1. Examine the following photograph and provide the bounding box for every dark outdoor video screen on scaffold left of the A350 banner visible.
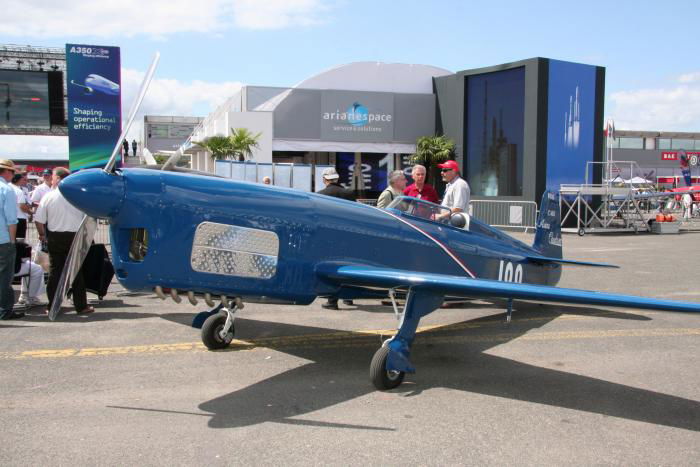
[0,70,51,129]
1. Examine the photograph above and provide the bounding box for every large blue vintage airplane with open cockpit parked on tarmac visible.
[52,167,700,390]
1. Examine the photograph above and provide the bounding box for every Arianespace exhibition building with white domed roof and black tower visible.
[188,58,605,201]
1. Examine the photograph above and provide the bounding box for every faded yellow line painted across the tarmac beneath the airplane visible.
[0,325,700,360]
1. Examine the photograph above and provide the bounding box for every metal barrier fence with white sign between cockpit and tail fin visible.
[469,200,537,232]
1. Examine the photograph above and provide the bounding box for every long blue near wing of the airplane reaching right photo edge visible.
[316,263,700,313]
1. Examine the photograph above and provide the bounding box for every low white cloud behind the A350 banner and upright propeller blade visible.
[0,69,241,159]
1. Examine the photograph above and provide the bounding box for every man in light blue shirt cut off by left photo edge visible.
[0,159,19,319]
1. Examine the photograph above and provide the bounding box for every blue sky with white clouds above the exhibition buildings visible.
[0,0,700,157]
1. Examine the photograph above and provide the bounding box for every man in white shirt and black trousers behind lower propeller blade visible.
[34,167,95,314]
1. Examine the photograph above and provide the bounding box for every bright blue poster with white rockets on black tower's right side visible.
[547,60,596,190]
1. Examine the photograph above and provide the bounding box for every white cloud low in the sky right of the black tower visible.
[607,73,700,131]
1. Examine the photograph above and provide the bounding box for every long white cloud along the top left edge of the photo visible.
[0,0,327,38]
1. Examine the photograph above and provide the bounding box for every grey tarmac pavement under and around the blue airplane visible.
[0,233,700,465]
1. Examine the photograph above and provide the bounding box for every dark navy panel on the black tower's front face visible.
[465,67,525,196]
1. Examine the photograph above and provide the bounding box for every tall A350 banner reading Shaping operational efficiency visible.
[66,44,121,170]
